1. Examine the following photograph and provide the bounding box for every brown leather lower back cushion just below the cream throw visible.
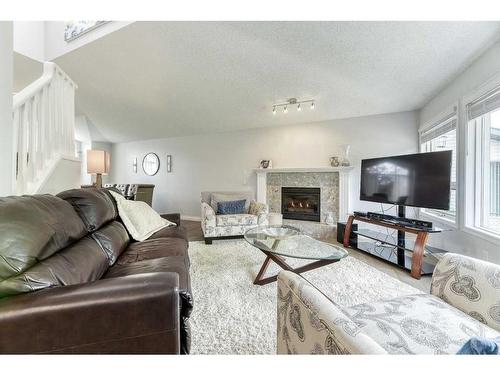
[92,221,130,266]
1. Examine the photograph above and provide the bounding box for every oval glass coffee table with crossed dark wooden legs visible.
[245,225,348,285]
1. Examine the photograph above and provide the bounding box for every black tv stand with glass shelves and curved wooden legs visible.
[344,206,443,279]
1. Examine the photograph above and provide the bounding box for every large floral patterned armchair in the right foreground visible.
[277,253,500,354]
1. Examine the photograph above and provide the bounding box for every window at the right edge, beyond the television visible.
[467,88,500,235]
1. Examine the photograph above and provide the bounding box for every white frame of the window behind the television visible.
[418,103,460,229]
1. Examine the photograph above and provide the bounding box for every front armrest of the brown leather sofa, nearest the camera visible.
[0,272,180,353]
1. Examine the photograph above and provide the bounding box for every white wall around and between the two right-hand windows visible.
[420,37,500,263]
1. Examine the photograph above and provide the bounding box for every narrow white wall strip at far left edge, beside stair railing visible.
[0,22,15,197]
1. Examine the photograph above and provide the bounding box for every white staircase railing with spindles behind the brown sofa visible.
[13,62,77,195]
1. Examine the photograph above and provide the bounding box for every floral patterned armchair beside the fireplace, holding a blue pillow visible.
[201,191,269,244]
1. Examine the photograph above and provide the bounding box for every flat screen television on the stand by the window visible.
[360,151,452,210]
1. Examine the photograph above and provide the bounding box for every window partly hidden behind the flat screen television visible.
[420,113,457,222]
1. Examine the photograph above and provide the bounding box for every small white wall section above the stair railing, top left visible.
[14,21,45,61]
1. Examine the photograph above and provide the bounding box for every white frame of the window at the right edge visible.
[460,74,500,245]
